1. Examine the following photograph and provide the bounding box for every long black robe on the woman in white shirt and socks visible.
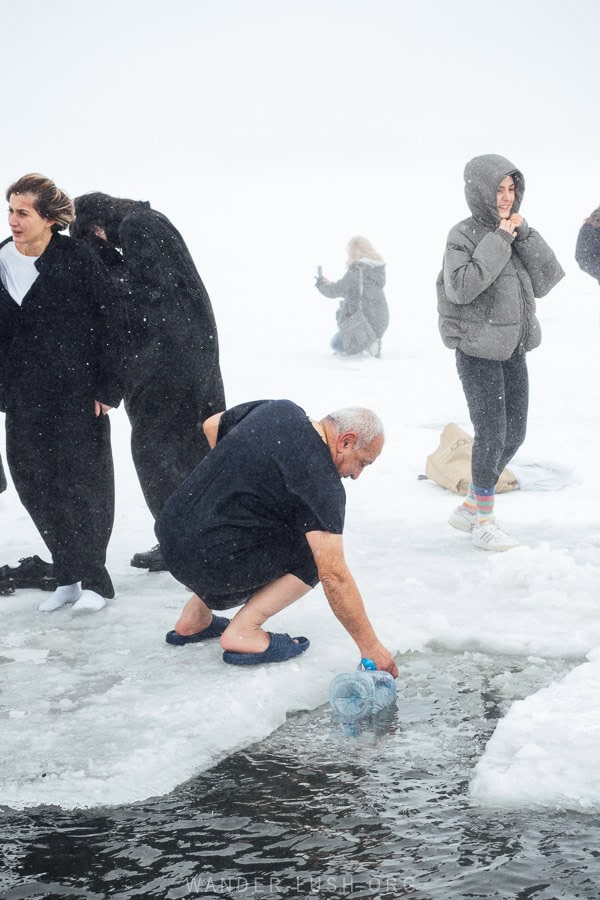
[0,234,123,597]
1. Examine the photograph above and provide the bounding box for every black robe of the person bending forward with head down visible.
[97,203,225,518]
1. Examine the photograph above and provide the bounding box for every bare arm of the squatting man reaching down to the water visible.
[306,531,398,677]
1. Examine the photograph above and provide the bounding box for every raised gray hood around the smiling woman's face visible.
[465,153,525,226]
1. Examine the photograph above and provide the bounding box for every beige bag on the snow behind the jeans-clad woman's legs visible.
[425,422,519,497]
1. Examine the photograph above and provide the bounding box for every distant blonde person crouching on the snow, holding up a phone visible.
[316,235,390,357]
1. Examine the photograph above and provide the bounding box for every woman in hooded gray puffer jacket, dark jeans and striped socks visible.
[437,154,564,550]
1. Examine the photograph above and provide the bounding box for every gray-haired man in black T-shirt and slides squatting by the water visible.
[156,400,398,676]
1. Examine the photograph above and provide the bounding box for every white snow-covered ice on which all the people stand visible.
[0,190,600,810]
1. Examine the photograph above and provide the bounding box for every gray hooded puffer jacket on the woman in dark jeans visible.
[436,154,565,360]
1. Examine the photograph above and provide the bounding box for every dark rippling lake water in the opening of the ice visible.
[0,652,600,900]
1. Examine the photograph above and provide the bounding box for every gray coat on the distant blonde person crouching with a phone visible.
[316,259,390,338]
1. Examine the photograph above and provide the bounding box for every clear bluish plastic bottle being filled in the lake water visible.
[329,658,396,722]
